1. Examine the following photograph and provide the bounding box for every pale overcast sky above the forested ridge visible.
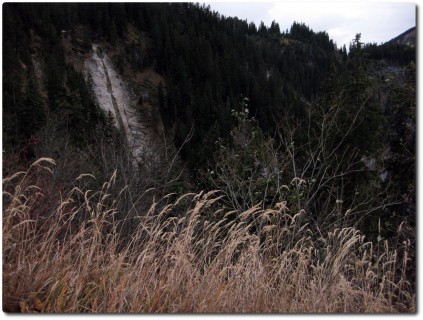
[206,0,416,48]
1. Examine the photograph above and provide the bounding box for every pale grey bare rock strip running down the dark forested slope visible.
[85,44,148,162]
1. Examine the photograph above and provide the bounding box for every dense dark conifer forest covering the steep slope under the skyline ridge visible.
[4,3,342,163]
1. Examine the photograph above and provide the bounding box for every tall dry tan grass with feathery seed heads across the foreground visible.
[3,159,416,313]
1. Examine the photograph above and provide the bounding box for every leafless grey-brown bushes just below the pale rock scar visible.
[31,120,189,233]
